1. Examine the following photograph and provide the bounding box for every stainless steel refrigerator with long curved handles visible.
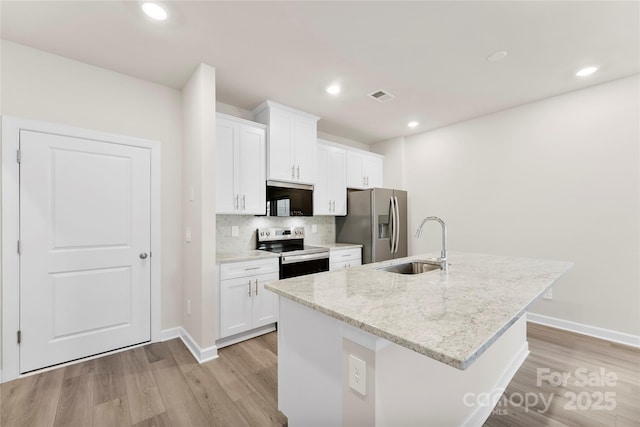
[336,188,407,264]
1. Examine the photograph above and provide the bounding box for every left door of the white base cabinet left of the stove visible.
[220,277,253,338]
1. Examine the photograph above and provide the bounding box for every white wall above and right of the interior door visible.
[0,41,182,344]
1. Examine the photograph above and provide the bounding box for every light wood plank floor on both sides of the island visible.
[0,324,640,427]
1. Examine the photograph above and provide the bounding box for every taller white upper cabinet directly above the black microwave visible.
[253,101,320,184]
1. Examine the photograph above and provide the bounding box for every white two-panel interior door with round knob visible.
[20,130,151,373]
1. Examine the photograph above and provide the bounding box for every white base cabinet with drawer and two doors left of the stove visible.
[220,258,279,338]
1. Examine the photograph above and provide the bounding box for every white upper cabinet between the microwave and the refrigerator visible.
[313,140,347,215]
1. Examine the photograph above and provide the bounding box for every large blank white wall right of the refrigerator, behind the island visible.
[374,75,640,335]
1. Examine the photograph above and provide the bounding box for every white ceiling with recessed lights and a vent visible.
[1,1,640,143]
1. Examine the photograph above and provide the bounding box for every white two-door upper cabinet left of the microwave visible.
[216,113,266,215]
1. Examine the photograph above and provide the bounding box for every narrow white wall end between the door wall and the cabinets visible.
[182,64,218,349]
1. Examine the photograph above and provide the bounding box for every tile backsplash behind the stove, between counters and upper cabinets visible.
[216,215,336,253]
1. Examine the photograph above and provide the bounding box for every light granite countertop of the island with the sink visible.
[265,252,573,369]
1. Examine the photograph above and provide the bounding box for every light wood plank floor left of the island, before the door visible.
[0,333,287,427]
